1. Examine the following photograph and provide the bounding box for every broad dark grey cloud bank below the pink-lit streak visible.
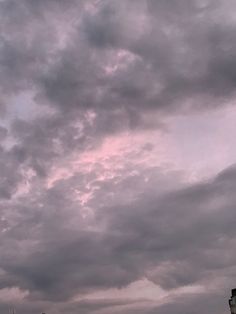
[1,164,235,300]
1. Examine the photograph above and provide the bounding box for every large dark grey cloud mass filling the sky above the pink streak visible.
[0,1,235,186]
